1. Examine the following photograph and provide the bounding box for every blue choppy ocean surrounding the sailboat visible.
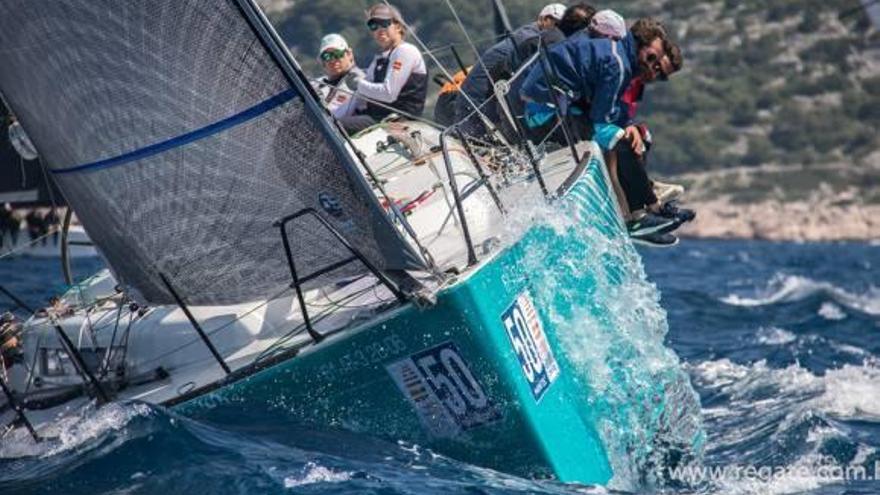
[0,240,880,495]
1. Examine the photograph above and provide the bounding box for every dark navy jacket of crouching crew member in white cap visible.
[455,22,565,131]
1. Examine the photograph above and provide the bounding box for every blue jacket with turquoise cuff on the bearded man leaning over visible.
[520,33,638,150]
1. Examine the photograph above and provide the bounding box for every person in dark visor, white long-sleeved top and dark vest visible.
[339,3,428,134]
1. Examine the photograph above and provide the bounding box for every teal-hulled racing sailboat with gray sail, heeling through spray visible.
[0,0,702,484]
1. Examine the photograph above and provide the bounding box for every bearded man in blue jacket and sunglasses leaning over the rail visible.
[520,19,677,244]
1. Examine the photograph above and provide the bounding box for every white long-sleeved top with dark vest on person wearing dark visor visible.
[357,41,428,120]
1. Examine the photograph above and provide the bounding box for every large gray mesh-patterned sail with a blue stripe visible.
[0,0,424,304]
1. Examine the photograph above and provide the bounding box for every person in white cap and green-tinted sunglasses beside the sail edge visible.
[312,33,364,119]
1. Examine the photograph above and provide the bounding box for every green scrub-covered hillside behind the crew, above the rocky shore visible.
[273,0,880,173]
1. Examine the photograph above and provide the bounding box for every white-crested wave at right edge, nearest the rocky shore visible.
[721,274,880,320]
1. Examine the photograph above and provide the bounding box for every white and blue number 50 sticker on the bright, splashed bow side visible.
[501,291,559,401]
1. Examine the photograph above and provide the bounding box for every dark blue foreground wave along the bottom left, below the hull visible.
[0,403,608,495]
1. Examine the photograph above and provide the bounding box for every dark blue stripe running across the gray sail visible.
[52,89,297,175]
